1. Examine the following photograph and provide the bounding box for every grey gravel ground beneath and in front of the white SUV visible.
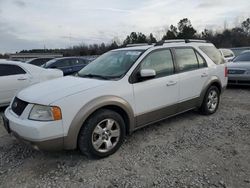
[0,88,250,188]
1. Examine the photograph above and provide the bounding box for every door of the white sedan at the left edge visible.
[0,64,30,105]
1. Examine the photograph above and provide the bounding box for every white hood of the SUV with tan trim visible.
[17,76,110,105]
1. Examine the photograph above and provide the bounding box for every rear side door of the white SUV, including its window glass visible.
[174,47,208,111]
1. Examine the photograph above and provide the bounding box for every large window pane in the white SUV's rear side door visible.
[175,48,199,72]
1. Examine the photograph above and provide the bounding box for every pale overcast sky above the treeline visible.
[0,0,250,53]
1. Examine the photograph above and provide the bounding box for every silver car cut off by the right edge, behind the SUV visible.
[227,52,250,86]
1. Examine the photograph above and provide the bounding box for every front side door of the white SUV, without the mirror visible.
[133,49,179,127]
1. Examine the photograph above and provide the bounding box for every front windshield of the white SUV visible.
[77,50,143,79]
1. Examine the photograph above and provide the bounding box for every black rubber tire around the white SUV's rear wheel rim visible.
[200,86,220,115]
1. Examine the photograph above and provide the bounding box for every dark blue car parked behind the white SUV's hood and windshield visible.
[42,57,92,76]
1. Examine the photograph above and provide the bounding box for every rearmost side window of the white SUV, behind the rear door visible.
[199,46,225,65]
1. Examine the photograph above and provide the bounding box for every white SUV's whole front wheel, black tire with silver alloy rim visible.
[78,109,125,158]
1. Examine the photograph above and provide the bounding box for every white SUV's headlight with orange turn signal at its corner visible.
[29,104,62,121]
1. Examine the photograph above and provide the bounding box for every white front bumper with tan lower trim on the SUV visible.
[3,108,64,151]
